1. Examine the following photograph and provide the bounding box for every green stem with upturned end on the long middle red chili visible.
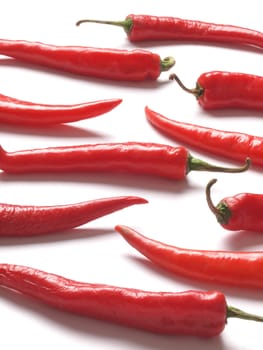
[188,155,251,173]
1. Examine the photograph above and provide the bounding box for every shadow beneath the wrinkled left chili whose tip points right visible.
[0,227,114,247]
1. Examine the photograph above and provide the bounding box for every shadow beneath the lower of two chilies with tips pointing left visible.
[127,255,263,302]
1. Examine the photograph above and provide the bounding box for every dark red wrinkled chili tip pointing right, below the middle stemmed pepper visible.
[0,196,147,236]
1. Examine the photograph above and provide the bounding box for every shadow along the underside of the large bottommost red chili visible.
[0,287,227,350]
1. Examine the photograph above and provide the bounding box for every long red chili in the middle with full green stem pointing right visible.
[0,142,250,180]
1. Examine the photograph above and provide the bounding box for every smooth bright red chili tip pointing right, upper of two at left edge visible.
[0,94,122,126]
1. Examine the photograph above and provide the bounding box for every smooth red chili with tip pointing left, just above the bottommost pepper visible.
[116,225,263,289]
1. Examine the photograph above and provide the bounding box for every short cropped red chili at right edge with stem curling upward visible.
[206,179,263,232]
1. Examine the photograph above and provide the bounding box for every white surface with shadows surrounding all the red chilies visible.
[0,0,263,350]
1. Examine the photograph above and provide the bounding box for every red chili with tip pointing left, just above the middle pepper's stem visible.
[145,107,263,166]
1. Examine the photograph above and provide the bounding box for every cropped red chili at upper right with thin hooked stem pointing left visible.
[169,71,263,111]
